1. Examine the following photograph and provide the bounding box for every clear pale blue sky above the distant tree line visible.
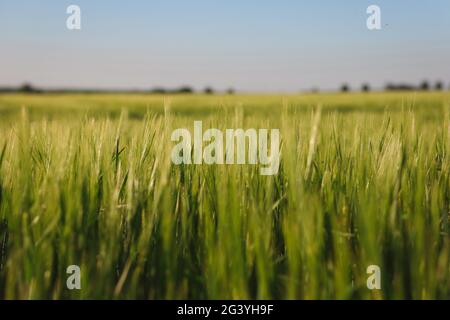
[0,0,450,92]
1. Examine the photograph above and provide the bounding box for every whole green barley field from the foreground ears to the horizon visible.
[0,92,450,299]
